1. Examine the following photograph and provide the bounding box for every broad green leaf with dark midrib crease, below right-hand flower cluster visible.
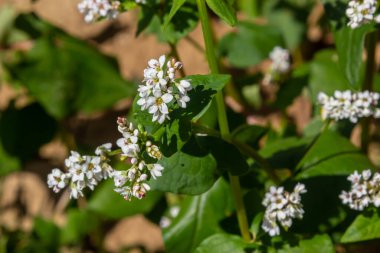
[296,131,373,179]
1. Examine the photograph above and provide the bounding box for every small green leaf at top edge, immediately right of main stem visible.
[206,0,237,26]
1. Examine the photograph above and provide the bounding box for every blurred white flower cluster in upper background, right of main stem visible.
[263,46,291,84]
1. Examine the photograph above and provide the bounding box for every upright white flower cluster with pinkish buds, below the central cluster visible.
[113,118,164,200]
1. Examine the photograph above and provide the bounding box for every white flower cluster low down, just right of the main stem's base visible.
[261,183,306,236]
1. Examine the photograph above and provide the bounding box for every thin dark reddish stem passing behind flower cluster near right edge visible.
[361,31,377,153]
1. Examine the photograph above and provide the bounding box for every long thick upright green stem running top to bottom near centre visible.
[197,0,251,242]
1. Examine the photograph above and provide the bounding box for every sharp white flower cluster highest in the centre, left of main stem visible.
[137,55,192,124]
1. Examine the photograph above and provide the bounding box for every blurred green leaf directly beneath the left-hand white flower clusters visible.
[87,180,162,220]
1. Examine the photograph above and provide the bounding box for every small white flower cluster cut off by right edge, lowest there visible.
[339,170,380,211]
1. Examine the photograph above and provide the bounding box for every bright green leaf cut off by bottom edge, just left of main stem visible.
[195,234,247,253]
